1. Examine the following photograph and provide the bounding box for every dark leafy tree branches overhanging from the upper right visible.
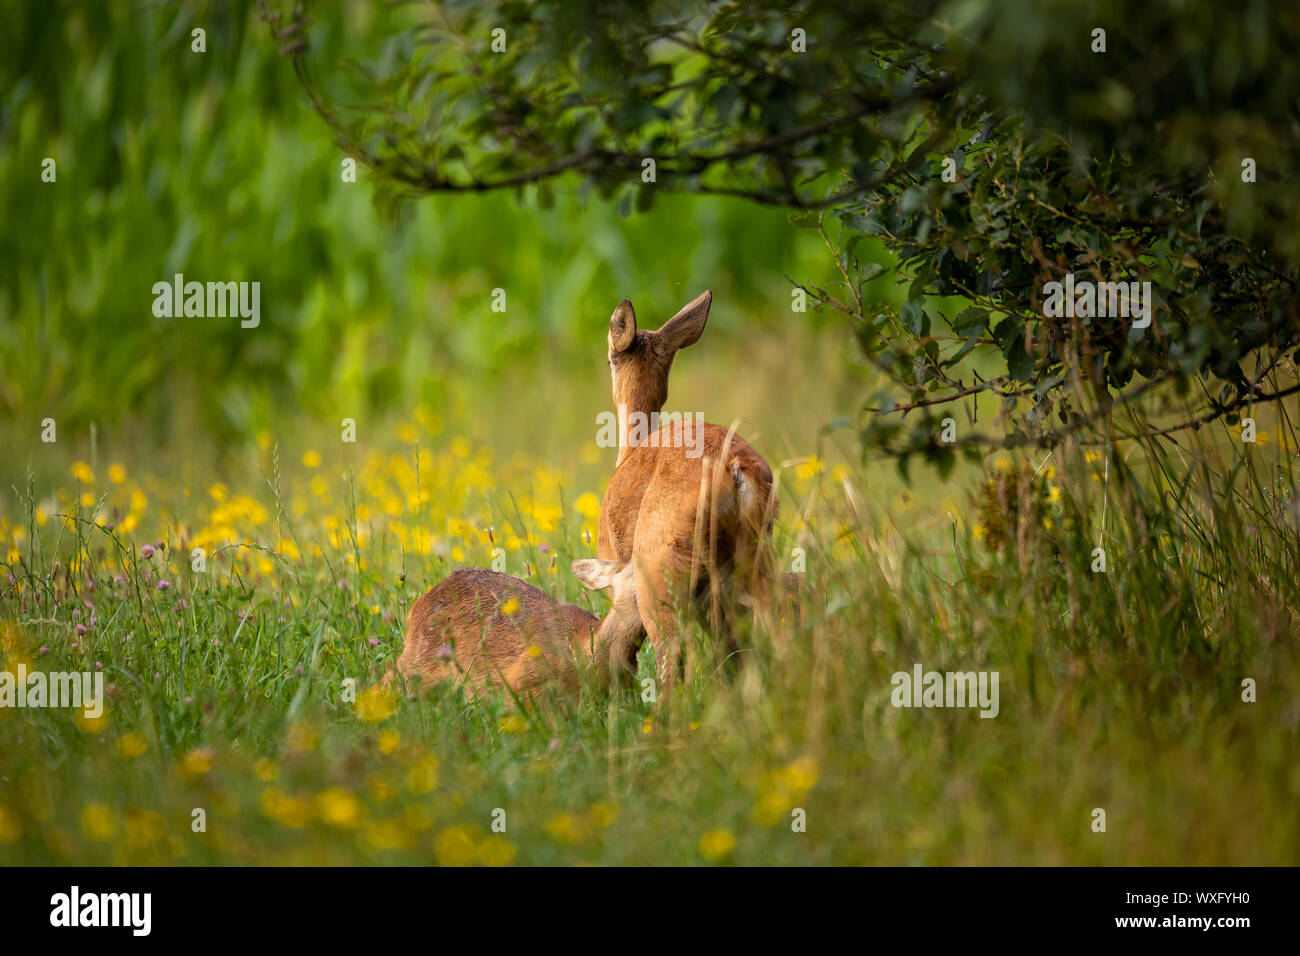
[267,0,1300,467]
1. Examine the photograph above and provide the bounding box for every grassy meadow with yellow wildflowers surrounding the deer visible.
[0,362,1300,865]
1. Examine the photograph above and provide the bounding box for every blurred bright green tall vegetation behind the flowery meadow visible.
[0,3,901,502]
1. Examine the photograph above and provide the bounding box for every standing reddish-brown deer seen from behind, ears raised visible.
[597,291,776,689]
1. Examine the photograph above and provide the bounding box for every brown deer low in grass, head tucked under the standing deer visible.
[384,559,641,698]
